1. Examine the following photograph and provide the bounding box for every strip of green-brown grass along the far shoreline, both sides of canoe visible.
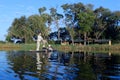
[0,43,120,53]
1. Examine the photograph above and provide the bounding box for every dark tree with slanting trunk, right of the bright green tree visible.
[93,7,111,39]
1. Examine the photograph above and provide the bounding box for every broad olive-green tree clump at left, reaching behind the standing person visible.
[7,15,48,43]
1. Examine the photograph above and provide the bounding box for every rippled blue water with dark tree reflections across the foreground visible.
[0,51,120,80]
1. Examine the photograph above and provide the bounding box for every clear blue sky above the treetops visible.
[0,0,120,41]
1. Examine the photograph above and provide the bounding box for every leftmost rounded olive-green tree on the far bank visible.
[8,16,31,43]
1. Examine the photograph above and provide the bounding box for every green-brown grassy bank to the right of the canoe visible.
[55,44,120,52]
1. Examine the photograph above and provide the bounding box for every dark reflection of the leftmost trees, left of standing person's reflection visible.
[8,51,36,80]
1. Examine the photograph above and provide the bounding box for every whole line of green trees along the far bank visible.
[6,2,120,44]
